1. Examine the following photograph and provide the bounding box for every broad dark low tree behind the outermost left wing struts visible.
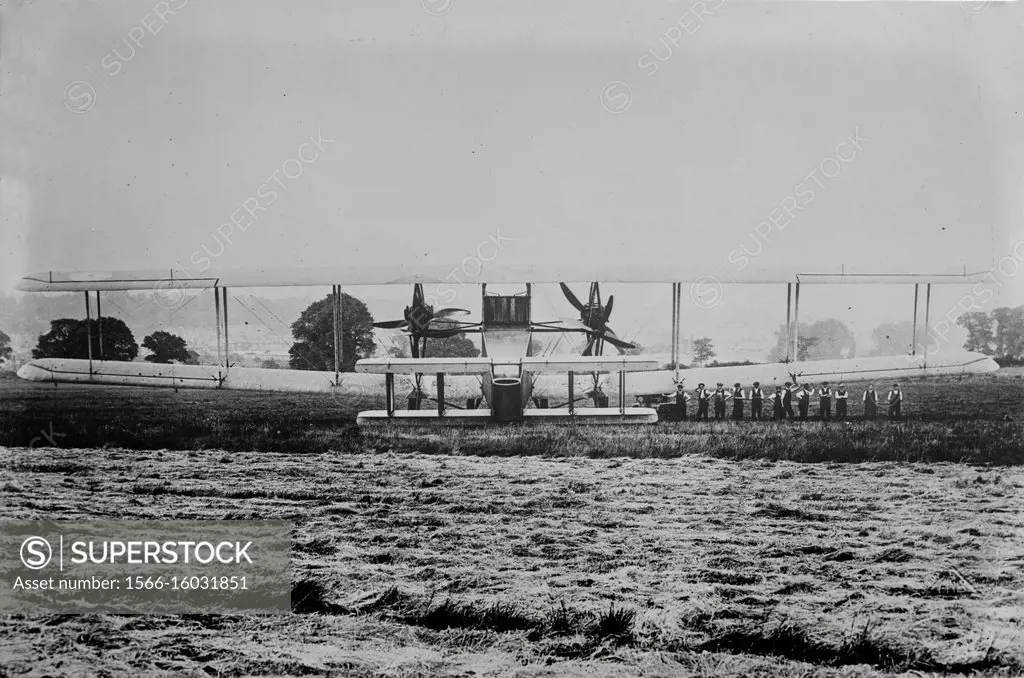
[32,315,138,361]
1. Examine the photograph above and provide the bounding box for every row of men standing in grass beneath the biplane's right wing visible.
[676,381,903,421]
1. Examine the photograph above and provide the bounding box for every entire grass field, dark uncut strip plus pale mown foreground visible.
[0,371,1024,676]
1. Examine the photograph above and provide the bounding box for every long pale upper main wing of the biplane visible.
[17,263,987,292]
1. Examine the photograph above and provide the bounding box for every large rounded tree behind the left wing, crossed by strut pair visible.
[288,293,375,372]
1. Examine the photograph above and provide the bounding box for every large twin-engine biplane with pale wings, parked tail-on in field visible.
[17,264,998,425]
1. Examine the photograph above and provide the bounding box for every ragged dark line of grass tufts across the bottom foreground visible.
[284,580,1024,674]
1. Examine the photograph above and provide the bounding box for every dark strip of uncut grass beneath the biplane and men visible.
[0,368,1024,464]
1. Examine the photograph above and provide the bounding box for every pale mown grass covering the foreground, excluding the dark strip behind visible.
[8,446,1024,678]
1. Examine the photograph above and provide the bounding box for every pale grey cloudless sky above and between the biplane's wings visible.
[0,0,1024,356]
